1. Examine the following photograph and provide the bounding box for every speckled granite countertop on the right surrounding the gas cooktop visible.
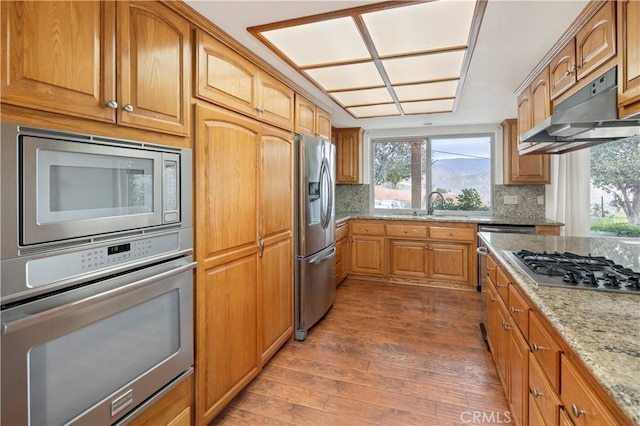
[478,232,640,425]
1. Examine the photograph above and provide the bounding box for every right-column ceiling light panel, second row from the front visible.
[382,50,465,84]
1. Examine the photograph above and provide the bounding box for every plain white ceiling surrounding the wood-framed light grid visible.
[185,0,587,130]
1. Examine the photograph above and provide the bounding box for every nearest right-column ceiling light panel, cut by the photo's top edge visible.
[362,0,476,57]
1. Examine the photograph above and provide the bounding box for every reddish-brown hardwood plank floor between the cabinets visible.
[212,279,509,425]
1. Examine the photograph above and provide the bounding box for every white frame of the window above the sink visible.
[367,131,496,216]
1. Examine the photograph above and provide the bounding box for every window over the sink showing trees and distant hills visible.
[371,134,494,215]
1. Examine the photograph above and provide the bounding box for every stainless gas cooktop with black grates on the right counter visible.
[504,250,640,294]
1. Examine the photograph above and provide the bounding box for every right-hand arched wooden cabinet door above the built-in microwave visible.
[117,1,191,135]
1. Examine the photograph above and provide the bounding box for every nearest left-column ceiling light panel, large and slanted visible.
[261,16,371,67]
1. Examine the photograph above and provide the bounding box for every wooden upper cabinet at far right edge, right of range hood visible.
[617,0,640,118]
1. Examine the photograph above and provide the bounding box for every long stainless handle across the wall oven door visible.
[2,262,198,334]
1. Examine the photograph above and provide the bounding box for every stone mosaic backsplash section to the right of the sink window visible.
[493,185,545,219]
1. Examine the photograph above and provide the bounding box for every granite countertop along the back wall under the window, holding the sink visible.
[336,213,564,226]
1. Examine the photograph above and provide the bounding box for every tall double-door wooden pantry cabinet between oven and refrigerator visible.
[195,105,293,423]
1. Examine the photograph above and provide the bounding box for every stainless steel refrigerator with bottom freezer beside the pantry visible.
[295,135,336,340]
